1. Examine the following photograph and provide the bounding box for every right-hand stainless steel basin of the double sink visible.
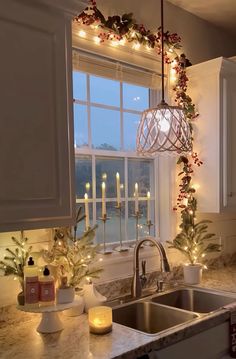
[152,288,236,313]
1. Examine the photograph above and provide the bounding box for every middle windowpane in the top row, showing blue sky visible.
[90,76,120,107]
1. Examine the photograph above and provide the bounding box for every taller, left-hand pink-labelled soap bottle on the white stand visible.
[24,257,39,308]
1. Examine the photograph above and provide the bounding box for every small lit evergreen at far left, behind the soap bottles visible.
[0,231,32,291]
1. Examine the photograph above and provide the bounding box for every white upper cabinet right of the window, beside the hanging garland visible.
[187,57,236,213]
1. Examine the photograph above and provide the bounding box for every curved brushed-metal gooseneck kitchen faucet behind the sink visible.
[131,237,170,298]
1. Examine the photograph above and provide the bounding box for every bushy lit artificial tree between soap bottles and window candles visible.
[43,207,102,288]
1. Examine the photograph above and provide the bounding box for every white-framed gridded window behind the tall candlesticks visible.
[73,71,156,243]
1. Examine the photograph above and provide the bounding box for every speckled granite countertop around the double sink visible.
[0,265,236,359]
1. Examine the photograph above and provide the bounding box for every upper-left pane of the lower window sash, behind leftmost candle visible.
[75,156,92,198]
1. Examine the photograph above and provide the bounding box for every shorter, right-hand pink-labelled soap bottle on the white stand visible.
[39,267,55,306]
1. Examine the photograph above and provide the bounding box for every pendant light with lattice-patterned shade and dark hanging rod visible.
[136,0,192,155]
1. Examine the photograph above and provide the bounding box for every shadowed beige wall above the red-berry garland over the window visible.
[97,0,236,64]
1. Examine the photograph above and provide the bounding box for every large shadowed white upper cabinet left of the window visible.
[0,0,75,231]
